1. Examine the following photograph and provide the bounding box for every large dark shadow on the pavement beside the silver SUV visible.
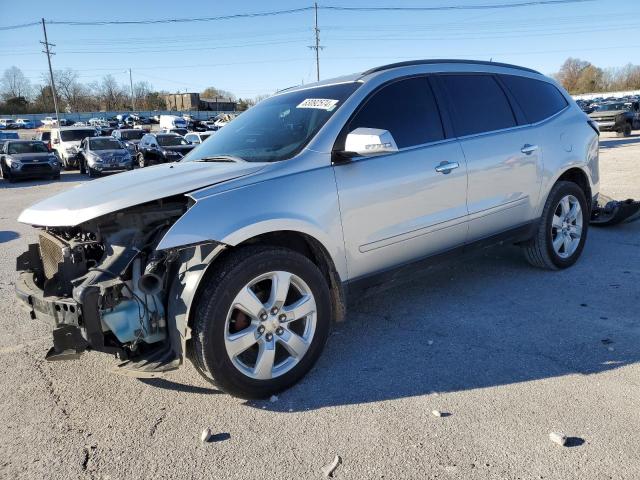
[245,222,640,412]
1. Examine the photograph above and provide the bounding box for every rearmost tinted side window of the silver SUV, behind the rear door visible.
[500,75,567,123]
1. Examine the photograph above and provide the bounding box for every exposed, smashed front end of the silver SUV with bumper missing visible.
[16,196,190,372]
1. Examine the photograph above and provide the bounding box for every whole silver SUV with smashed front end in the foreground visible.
[17,60,598,398]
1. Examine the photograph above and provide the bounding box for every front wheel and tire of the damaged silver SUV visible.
[190,246,333,399]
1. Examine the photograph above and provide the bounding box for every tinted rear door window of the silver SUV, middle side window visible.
[440,75,516,136]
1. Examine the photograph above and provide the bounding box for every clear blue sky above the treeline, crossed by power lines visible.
[0,0,640,97]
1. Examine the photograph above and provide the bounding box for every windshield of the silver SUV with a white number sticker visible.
[183,82,360,162]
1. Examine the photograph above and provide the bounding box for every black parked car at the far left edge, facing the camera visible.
[0,140,60,182]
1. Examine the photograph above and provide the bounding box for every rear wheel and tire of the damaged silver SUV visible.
[524,181,590,270]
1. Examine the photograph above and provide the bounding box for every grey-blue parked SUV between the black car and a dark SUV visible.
[78,137,133,177]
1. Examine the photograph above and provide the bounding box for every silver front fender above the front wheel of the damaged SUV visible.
[157,166,347,279]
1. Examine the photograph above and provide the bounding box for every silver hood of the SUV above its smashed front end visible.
[18,162,264,227]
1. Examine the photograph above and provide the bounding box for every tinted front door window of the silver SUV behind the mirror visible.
[349,77,444,148]
